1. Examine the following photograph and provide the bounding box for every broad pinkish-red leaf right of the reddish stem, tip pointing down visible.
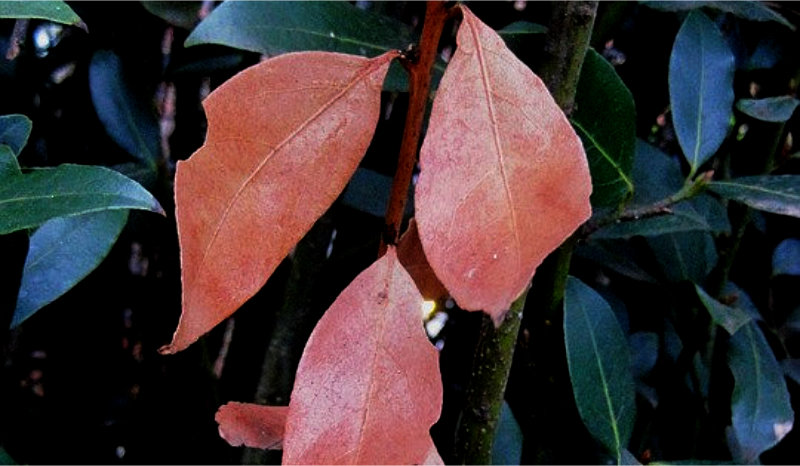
[416,5,591,323]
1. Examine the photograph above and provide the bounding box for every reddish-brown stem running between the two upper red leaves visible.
[379,1,451,256]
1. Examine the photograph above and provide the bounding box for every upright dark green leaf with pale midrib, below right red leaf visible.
[564,277,636,463]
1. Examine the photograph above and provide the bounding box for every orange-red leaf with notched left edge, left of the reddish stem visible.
[161,52,397,353]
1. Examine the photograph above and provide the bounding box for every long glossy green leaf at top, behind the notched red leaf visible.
[185,1,412,91]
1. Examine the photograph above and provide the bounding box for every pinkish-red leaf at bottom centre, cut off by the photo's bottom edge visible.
[283,247,442,464]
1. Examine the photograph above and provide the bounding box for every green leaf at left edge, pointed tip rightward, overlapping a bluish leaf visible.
[0,164,164,234]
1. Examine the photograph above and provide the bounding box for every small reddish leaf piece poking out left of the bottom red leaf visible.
[214,402,289,450]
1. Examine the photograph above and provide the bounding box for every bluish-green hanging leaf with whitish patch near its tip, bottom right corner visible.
[728,322,794,464]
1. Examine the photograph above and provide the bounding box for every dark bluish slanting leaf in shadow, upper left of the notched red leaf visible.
[89,50,161,171]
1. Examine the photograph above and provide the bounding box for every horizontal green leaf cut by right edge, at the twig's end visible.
[709,175,800,217]
